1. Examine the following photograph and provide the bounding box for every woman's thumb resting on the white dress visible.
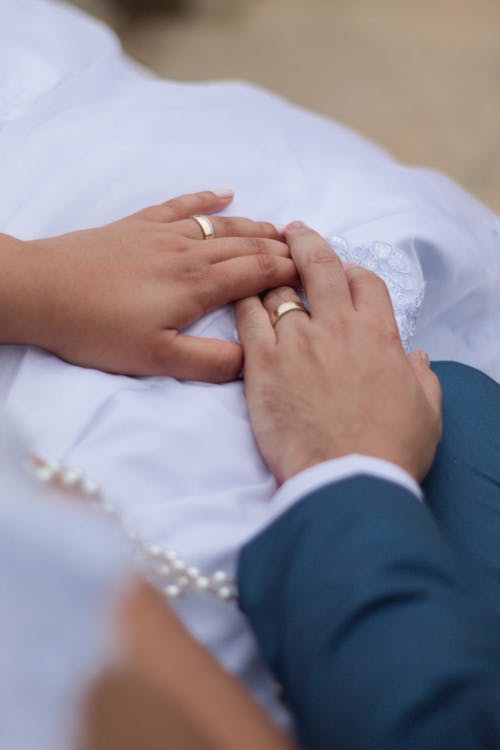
[155,331,243,383]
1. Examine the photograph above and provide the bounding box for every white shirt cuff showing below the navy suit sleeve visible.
[272,453,424,516]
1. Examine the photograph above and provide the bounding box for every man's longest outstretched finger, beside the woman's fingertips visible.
[285,222,352,319]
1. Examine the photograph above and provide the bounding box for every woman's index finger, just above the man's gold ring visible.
[207,255,298,307]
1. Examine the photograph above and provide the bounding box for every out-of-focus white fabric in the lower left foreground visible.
[0,426,131,750]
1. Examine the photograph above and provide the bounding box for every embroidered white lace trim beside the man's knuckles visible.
[328,236,425,352]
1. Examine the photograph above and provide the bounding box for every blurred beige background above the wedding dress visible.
[74,0,500,212]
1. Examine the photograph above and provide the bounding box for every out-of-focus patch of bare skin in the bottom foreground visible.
[79,581,295,750]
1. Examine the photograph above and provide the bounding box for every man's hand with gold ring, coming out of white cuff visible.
[236,223,441,482]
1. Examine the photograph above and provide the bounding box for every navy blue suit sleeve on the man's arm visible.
[239,476,500,750]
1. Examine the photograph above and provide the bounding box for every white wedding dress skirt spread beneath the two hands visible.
[0,0,500,736]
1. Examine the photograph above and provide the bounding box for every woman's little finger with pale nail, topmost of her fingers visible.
[129,190,234,223]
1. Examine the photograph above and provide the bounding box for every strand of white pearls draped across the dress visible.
[30,456,237,602]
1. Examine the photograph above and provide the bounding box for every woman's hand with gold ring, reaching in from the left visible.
[7,192,295,382]
